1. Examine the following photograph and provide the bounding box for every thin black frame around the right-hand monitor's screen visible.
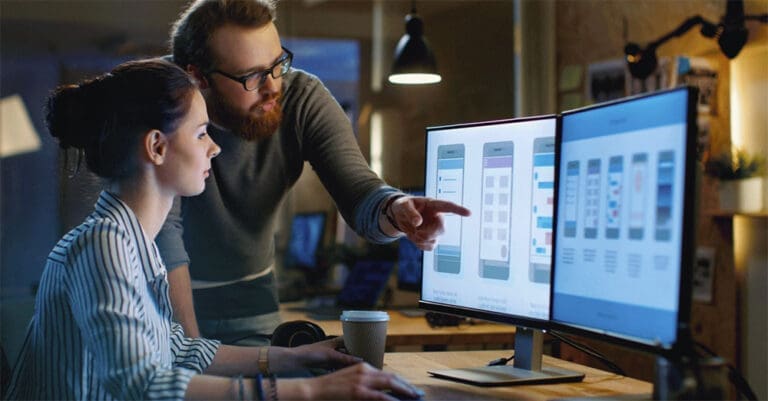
[549,86,698,356]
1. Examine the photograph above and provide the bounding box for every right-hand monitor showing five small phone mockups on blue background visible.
[551,88,696,349]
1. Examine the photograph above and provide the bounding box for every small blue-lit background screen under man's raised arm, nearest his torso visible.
[284,212,325,269]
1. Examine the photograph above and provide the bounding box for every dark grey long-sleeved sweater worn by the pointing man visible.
[156,69,396,316]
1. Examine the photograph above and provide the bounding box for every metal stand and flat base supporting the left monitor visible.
[428,326,584,386]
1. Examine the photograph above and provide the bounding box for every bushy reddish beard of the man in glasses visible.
[208,88,283,141]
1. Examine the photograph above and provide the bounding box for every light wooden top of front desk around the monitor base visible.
[384,351,653,400]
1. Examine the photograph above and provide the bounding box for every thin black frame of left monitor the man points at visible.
[419,114,560,330]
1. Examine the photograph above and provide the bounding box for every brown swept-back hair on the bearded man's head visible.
[171,0,277,72]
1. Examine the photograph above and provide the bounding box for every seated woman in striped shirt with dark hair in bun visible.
[7,59,415,400]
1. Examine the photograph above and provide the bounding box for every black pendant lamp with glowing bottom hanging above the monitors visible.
[389,14,441,84]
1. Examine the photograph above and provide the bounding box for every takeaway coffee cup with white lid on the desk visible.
[341,310,389,369]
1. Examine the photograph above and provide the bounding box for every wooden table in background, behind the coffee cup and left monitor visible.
[280,303,515,347]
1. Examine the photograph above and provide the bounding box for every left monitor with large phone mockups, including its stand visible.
[419,115,583,385]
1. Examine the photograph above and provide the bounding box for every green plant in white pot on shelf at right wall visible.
[704,148,765,212]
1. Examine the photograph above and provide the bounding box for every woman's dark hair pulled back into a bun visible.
[43,58,196,180]
